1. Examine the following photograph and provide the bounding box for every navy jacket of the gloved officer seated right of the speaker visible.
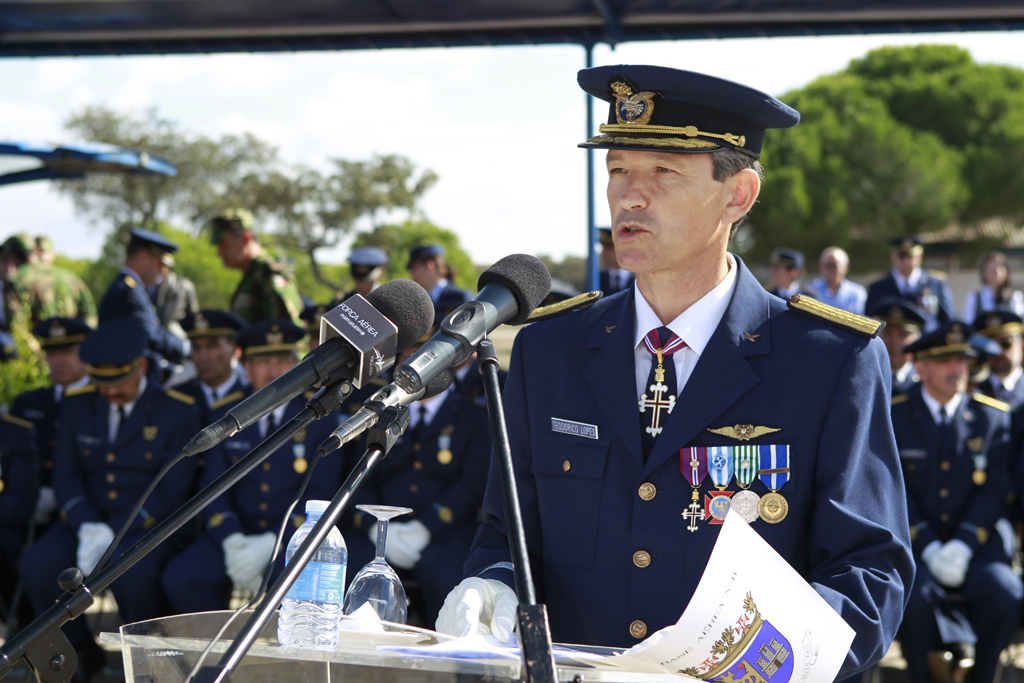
[892,385,1013,561]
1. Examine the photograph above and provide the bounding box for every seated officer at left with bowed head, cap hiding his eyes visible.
[18,318,200,672]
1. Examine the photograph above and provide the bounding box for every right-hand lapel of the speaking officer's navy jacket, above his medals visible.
[644,258,771,471]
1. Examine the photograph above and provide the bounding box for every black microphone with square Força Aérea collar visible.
[183,280,434,456]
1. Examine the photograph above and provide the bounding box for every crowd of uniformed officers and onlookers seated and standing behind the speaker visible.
[6,215,1024,681]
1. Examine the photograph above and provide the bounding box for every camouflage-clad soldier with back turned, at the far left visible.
[11,236,96,326]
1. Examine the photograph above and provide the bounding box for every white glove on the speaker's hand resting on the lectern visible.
[434,577,519,643]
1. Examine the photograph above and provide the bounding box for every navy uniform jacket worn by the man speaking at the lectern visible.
[466,258,913,678]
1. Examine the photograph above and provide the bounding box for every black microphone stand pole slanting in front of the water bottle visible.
[194,405,411,683]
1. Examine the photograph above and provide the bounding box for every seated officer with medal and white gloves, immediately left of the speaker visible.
[345,333,492,625]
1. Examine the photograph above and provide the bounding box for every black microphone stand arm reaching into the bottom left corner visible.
[0,380,352,683]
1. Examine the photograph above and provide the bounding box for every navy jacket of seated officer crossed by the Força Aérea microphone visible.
[200,396,342,544]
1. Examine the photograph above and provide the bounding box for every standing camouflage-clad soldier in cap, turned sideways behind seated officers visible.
[210,209,303,325]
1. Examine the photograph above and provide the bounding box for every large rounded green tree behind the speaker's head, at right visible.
[749,45,1024,269]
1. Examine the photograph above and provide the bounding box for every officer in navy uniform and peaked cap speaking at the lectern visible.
[437,66,913,678]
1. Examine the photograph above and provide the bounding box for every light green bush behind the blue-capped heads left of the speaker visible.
[352,220,478,292]
